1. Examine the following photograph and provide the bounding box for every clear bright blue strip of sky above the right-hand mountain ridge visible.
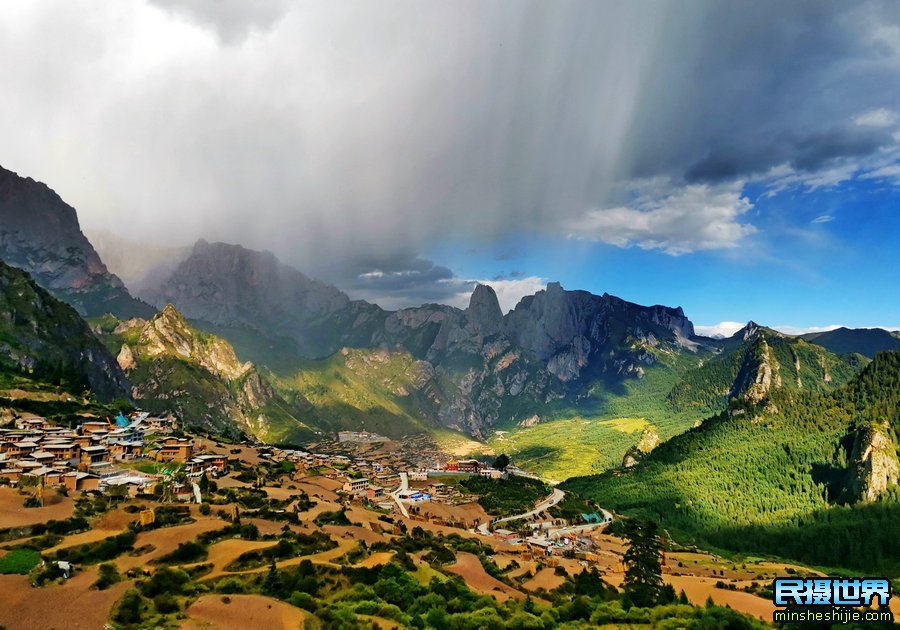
[428,179,900,331]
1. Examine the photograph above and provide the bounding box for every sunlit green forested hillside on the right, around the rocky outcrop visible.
[564,353,900,574]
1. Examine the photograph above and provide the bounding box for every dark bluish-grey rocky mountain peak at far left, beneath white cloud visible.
[0,167,152,316]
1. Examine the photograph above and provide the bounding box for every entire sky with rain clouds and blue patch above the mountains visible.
[0,0,900,333]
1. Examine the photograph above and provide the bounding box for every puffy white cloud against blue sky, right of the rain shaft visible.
[566,179,756,256]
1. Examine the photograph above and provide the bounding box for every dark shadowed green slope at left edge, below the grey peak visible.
[0,262,129,401]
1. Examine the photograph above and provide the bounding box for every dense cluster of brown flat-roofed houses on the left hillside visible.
[0,412,227,496]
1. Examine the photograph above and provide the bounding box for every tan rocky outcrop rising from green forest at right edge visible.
[844,423,900,503]
